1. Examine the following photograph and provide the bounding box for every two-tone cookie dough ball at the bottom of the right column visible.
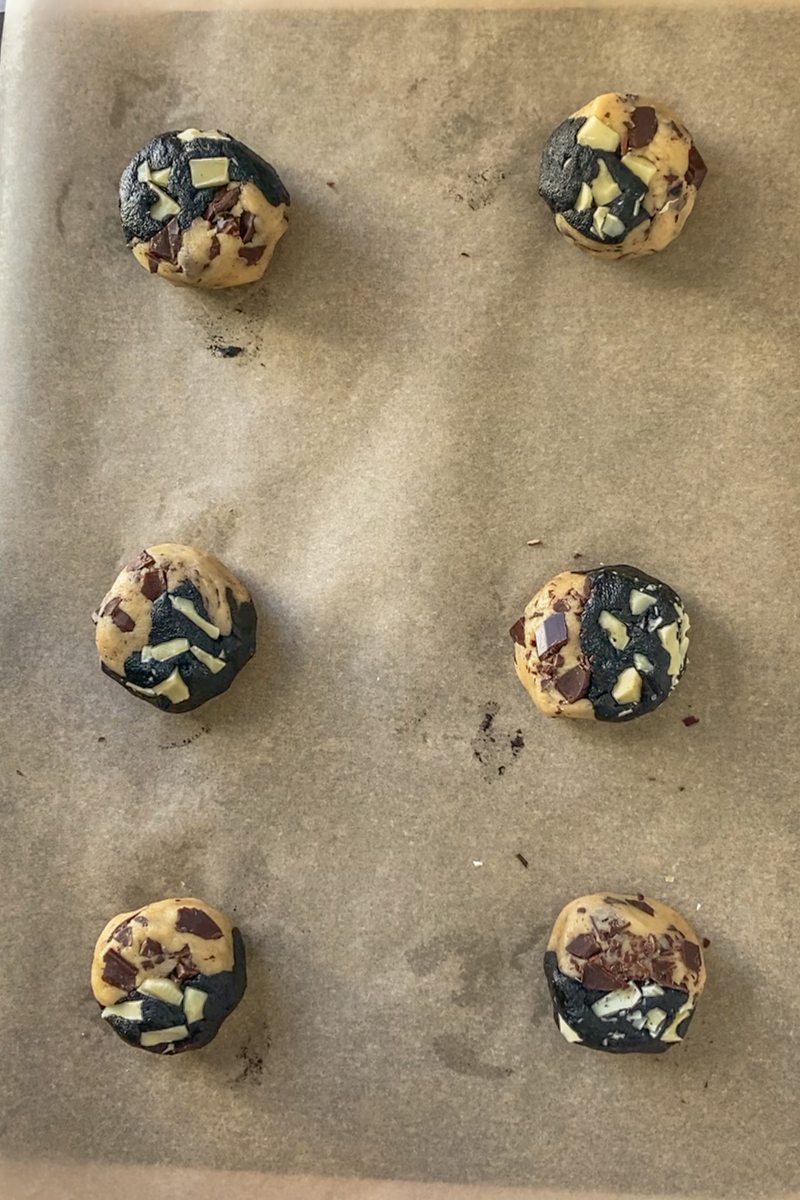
[545,892,705,1054]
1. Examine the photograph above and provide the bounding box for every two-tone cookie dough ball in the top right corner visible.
[539,91,705,258]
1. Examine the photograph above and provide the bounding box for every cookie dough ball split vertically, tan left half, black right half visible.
[511,565,690,721]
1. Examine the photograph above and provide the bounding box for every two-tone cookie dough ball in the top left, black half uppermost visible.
[120,130,289,288]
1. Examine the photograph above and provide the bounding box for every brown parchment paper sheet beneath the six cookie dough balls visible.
[0,7,800,1200]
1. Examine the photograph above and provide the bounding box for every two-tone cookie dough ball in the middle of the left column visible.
[92,542,255,713]
